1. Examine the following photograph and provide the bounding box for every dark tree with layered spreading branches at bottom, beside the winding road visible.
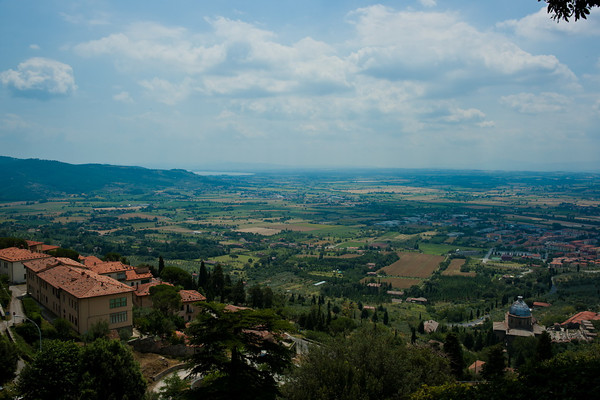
[187,303,291,400]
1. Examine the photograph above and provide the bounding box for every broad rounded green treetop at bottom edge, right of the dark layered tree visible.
[283,326,453,400]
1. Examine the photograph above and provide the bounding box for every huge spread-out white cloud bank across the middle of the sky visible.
[69,2,577,141]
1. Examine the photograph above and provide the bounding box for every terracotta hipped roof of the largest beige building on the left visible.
[38,265,135,298]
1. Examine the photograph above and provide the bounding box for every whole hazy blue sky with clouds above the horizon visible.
[0,0,600,171]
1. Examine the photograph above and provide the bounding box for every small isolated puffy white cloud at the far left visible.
[0,57,77,96]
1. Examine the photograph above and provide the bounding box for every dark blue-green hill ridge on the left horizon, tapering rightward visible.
[0,156,223,201]
